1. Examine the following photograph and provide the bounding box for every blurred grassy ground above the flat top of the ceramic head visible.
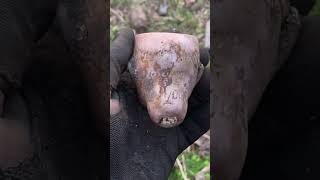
[110,0,210,47]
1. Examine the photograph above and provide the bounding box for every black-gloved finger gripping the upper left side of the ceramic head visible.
[110,28,134,89]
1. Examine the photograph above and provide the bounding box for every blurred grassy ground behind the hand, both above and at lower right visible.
[110,0,210,180]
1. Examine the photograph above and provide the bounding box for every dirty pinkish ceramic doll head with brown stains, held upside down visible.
[129,33,203,128]
